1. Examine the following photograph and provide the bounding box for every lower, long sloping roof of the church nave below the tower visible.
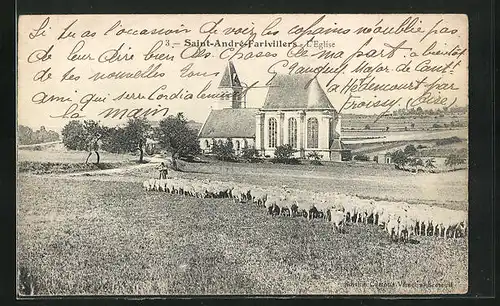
[198,108,258,138]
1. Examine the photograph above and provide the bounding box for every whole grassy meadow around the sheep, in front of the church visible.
[16,133,468,295]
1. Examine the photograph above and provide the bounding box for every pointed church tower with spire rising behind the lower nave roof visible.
[219,61,246,108]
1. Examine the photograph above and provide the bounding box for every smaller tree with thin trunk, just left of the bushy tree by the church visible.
[122,118,151,163]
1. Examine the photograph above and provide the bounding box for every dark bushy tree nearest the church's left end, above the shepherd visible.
[155,113,201,168]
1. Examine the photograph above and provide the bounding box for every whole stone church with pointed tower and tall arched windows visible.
[198,62,349,161]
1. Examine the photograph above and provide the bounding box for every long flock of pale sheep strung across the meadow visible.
[143,177,468,242]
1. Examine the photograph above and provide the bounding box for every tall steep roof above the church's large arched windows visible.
[262,74,334,109]
